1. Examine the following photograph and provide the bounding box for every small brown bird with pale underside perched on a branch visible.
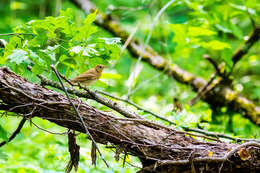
[71,64,105,86]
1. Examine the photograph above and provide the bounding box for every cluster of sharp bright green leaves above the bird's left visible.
[1,9,120,83]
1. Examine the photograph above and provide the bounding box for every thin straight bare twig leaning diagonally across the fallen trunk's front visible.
[51,65,110,168]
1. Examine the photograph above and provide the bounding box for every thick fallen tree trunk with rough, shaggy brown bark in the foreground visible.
[0,67,260,172]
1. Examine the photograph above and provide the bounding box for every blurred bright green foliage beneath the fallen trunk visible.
[0,117,140,173]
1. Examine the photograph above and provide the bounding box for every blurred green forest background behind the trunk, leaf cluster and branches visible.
[0,0,260,173]
